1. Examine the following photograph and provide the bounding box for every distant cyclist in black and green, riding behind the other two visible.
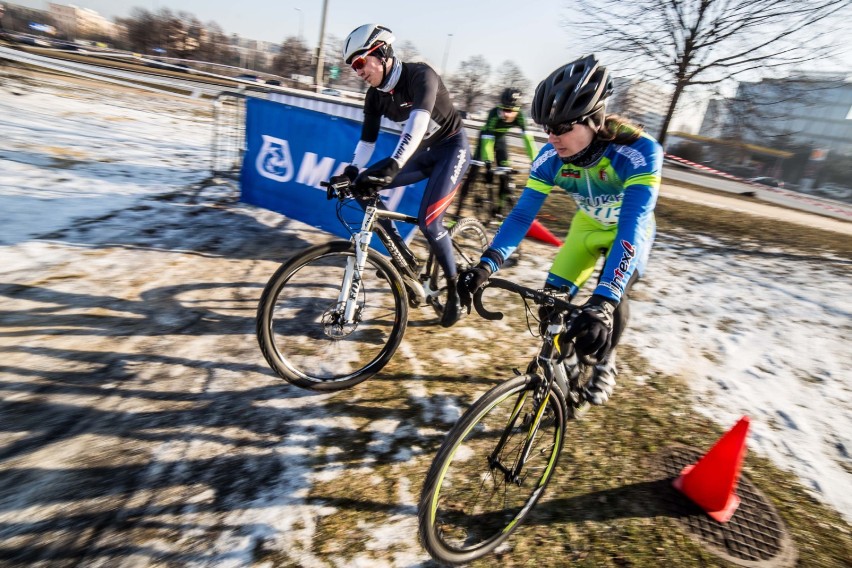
[456,88,536,217]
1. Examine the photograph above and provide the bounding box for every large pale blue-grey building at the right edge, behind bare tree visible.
[699,73,852,156]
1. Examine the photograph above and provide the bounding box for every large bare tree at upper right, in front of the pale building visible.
[570,0,852,143]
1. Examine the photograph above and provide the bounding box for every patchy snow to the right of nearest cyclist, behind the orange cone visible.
[629,231,852,519]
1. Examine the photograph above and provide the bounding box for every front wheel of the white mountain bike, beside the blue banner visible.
[257,241,408,391]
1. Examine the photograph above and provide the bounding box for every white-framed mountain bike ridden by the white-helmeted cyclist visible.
[256,178,489,391]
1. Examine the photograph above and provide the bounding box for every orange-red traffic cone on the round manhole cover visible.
[672,416,749,523]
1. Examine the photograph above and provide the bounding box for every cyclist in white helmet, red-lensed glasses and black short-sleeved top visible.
[330,24,470,327]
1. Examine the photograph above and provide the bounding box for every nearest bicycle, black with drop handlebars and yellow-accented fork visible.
[418,278,595,564]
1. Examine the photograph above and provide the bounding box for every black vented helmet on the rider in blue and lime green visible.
[530,55,612,126]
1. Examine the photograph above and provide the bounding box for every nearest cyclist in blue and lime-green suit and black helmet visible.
[459,55,663,404]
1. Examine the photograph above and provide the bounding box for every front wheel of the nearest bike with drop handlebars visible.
[418,375,565,564]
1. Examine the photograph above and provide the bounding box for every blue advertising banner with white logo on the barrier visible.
[240,98,426,245]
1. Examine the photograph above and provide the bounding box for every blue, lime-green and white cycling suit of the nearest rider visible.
[482,133,663,302]
